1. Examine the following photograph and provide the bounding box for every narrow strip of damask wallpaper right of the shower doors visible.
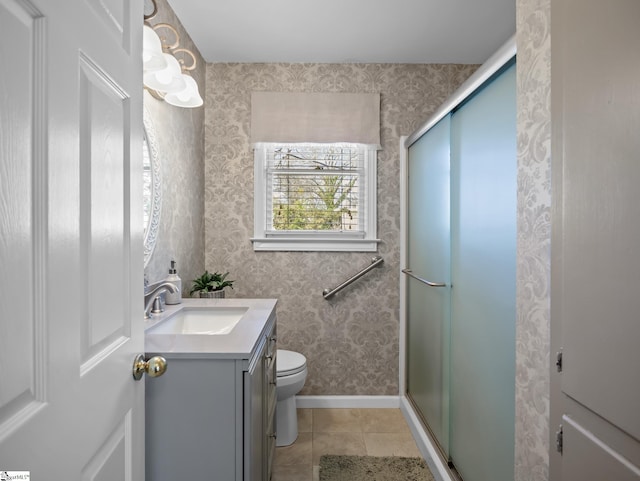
[515,0,551,481]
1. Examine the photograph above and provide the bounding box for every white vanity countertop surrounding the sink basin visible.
[145,298,277,359]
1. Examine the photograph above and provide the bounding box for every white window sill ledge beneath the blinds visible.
[251,237,381,252]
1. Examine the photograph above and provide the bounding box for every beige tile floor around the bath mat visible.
[271,409,420,481]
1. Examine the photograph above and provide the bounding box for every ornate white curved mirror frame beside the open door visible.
[143,108,162,267]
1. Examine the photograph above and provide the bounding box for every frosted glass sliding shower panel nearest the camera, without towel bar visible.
[450,65,517,481]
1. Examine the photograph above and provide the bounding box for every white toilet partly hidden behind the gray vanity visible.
[276,349,307,446]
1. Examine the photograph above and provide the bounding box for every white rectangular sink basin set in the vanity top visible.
[148,306,249,336]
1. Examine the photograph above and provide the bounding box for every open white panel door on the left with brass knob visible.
[0,0,144,481]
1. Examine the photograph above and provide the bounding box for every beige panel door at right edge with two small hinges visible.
[551,0,640,481]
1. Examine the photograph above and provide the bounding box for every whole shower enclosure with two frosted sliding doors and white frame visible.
[402,40,517,481]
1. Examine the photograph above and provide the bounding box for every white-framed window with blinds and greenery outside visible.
[252,143,378,251]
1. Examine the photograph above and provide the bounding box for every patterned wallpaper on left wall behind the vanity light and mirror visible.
[144,0,205,295]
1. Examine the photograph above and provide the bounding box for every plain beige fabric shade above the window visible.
[251,92,380,149]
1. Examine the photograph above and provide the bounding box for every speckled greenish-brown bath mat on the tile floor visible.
[320,454,434,481]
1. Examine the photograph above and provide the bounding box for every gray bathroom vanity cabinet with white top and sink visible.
[145,299,277,481]
